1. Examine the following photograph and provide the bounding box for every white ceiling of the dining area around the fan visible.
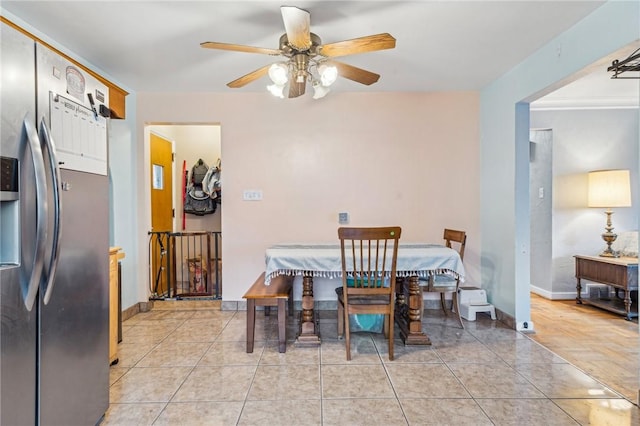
[0,0,638,103]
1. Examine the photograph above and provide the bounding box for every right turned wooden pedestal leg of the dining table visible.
[395,276,431,345]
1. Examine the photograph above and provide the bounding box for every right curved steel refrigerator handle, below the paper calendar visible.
[39,117,62,305]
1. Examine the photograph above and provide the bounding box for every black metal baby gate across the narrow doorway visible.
[149,231,222,299]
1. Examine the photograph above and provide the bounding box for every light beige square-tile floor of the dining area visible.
[102,301,640,426]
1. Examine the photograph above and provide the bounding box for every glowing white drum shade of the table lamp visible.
[587,170,631,208]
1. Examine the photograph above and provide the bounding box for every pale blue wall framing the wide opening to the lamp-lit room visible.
[480,1,640,321]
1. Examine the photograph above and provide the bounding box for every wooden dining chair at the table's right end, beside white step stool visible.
[420,228,467,329]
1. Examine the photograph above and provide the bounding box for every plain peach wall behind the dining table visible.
[136,92,480,301]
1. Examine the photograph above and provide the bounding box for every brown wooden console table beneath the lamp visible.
[574,255,638,320]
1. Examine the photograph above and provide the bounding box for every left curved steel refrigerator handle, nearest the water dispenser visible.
[22,115,48,311]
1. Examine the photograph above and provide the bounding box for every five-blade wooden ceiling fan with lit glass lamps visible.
[200,6,396,99]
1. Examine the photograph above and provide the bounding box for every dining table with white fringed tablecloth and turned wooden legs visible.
[265,243,465,345]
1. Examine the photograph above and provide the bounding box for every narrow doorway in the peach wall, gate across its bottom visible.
[145,123,222,299]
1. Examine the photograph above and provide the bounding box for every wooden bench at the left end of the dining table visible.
[242,272,293,353]
